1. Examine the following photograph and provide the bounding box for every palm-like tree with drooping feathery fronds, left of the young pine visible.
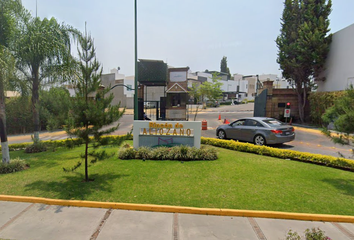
[14,17,75,140]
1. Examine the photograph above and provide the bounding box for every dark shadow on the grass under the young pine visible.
[25,173,129,200]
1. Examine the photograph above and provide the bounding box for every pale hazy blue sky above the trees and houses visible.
[22,0,354,76]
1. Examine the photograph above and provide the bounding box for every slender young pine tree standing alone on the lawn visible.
[66,28,124,181]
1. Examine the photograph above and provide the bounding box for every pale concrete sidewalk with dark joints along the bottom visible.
[0,201,354,240]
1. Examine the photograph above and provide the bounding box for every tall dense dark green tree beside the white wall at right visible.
[276,0,332,122]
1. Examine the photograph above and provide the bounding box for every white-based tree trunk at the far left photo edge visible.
[0,73,10,163]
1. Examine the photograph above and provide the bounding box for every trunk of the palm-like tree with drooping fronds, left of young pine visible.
[32,69,40,141]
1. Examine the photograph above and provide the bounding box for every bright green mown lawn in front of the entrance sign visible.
[0,142,354,215]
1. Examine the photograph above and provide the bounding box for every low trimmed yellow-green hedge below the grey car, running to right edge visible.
[201,137,354,171]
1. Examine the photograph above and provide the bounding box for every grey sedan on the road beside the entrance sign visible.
[216,117,295,146]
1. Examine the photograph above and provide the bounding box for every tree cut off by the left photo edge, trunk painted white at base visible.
[0,0,24,163]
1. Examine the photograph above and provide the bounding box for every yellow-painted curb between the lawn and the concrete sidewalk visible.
[0,195,354,223]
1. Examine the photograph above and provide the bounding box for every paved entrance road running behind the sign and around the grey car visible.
[9,103,353,158]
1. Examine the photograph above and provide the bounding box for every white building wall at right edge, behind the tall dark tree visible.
[316,24,354,92]
